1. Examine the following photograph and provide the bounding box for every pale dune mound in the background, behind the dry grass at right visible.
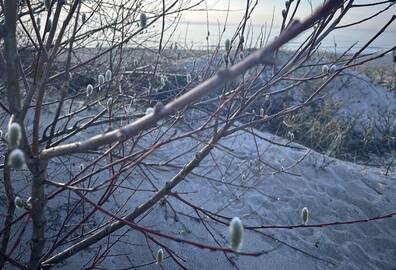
[174,52,396,132]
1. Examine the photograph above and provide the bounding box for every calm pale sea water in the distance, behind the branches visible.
[168,22,396,52]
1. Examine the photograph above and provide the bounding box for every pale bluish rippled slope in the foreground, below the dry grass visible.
[45,123,396,269]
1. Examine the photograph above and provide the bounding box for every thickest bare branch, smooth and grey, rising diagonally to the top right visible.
[40,0,343,159]
